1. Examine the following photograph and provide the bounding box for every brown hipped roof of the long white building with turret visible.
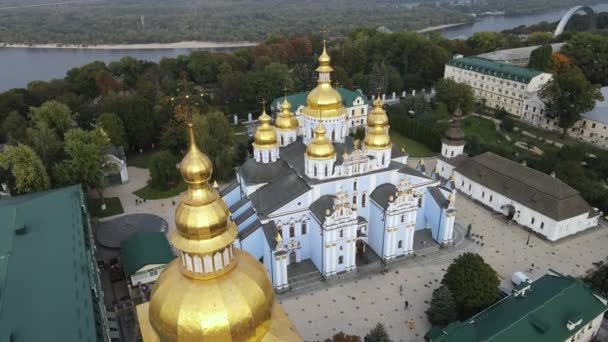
[455,152,591,221]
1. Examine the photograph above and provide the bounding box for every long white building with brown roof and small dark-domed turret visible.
[437,121,602,241]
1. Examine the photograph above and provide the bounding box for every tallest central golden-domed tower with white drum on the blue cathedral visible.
[302,41,347,145]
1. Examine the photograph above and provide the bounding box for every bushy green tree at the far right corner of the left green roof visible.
[53,128,111,202]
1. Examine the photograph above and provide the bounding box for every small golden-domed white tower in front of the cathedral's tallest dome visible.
[304,123,336,179]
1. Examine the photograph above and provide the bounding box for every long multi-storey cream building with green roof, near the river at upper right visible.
[444,57,552,116]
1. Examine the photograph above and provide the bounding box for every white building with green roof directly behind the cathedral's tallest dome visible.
[272,87,369,136]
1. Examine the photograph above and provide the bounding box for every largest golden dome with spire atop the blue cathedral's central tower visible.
[302,43,346,118]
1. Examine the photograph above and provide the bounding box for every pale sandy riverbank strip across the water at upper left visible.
[0,41,258,50]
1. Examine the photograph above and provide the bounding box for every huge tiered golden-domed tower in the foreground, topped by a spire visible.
[143,107,302,342]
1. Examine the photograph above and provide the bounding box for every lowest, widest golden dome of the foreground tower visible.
[145,248,302,342]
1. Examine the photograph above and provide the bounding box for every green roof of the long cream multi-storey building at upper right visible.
[448,57,542,83]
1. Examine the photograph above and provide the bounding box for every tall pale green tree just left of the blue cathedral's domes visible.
[193,111,238,180]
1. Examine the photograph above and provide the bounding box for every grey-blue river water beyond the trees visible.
[0,4,608,91]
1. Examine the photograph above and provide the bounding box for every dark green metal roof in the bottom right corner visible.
[428,273,608,342]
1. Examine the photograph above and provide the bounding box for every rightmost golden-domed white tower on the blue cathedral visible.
[363,96,393,167]
